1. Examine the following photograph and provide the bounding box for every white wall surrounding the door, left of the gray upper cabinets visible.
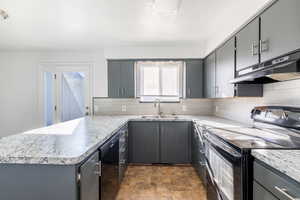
[0,51,107,137]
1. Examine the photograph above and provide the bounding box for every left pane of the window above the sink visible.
[142,66,159,95]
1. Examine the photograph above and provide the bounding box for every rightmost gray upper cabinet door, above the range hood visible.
[261,0,300,62]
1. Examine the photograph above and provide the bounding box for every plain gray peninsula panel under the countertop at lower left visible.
[0,164,78,200]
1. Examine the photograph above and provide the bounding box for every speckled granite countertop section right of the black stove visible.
[252,149,300,183]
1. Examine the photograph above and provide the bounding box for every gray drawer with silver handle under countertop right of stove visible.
[254,162,300,200]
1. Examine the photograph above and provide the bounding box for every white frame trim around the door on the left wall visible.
[37,62,94,126]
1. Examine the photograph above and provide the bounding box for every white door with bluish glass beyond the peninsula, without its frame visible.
[43,66,91,126]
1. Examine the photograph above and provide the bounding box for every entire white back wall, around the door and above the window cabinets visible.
[0,46,202,137]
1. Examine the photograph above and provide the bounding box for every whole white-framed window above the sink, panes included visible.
[135,61,184,102]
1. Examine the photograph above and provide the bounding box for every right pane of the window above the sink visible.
[161,64,179,96]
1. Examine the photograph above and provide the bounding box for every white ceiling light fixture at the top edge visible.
[153,0,182,15]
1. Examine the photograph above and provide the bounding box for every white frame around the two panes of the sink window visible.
[135,60,185,102]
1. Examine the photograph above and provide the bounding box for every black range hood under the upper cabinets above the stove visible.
[230,51,300,84]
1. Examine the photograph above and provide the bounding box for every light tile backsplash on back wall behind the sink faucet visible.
[94,98,213,115]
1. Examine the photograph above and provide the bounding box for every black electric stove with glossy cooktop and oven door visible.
[204,106,300,200]
